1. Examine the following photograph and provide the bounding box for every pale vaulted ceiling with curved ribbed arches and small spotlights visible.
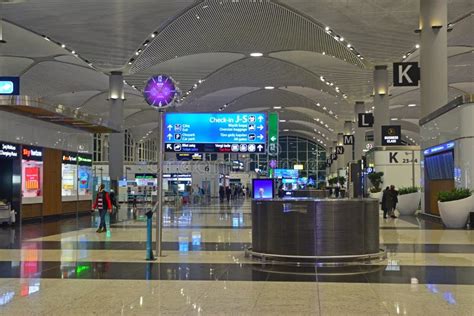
[0,0,474,146]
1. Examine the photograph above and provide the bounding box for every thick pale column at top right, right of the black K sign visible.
[420,0,448,117]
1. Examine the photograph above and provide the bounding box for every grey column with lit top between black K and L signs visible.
[374,65,390,146]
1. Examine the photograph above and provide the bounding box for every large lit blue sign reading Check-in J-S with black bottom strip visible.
[163,113,267,153]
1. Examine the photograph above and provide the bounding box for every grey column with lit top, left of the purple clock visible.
[109,71,125,182]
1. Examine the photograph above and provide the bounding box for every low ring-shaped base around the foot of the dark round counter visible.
[245,248,387,267]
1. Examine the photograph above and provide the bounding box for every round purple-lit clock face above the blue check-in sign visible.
[143,75,177,108]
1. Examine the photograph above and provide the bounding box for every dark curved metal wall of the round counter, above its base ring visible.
[251,198,380,259]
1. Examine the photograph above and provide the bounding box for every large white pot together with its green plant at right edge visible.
[438,188,474,228]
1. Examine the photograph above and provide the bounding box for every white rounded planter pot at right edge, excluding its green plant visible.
[438,195,474,228]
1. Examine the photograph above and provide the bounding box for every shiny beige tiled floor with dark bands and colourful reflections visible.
[0,201,474,315]
